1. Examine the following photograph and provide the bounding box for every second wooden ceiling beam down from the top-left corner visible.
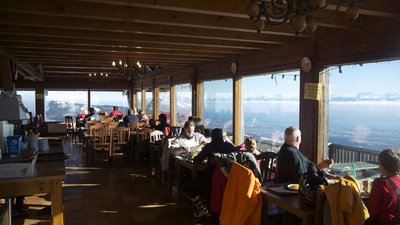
[0,12,295,44]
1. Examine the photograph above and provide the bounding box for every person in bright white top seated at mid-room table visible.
[171,121,207,155]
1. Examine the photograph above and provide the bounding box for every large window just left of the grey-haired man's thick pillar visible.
[242,71,300,143]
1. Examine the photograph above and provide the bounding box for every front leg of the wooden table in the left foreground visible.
[51,179,64,225]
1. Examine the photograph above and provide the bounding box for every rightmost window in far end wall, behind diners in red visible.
[90,90,129,115]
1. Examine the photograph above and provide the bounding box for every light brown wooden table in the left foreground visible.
[0,157,65,225]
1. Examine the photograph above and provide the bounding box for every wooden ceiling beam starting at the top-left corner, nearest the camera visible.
[0,0,306,36]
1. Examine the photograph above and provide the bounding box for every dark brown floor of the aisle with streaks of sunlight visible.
[7,137,217,225]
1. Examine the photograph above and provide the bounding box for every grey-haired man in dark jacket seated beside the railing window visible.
[276,126,334,183]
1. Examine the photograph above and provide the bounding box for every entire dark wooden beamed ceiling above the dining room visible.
[0,0,400,79]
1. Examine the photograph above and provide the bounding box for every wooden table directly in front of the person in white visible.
[175,156,208,194]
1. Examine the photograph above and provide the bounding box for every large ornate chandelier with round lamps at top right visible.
[247,0,365,35]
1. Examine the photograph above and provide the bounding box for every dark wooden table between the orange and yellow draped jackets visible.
[261,187,316,225]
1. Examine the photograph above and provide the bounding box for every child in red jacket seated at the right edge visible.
[365,149,400,225]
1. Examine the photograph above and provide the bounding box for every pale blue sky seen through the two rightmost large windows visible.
[238,60,400,97]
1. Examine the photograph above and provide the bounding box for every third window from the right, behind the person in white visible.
[203,79,233,134]
